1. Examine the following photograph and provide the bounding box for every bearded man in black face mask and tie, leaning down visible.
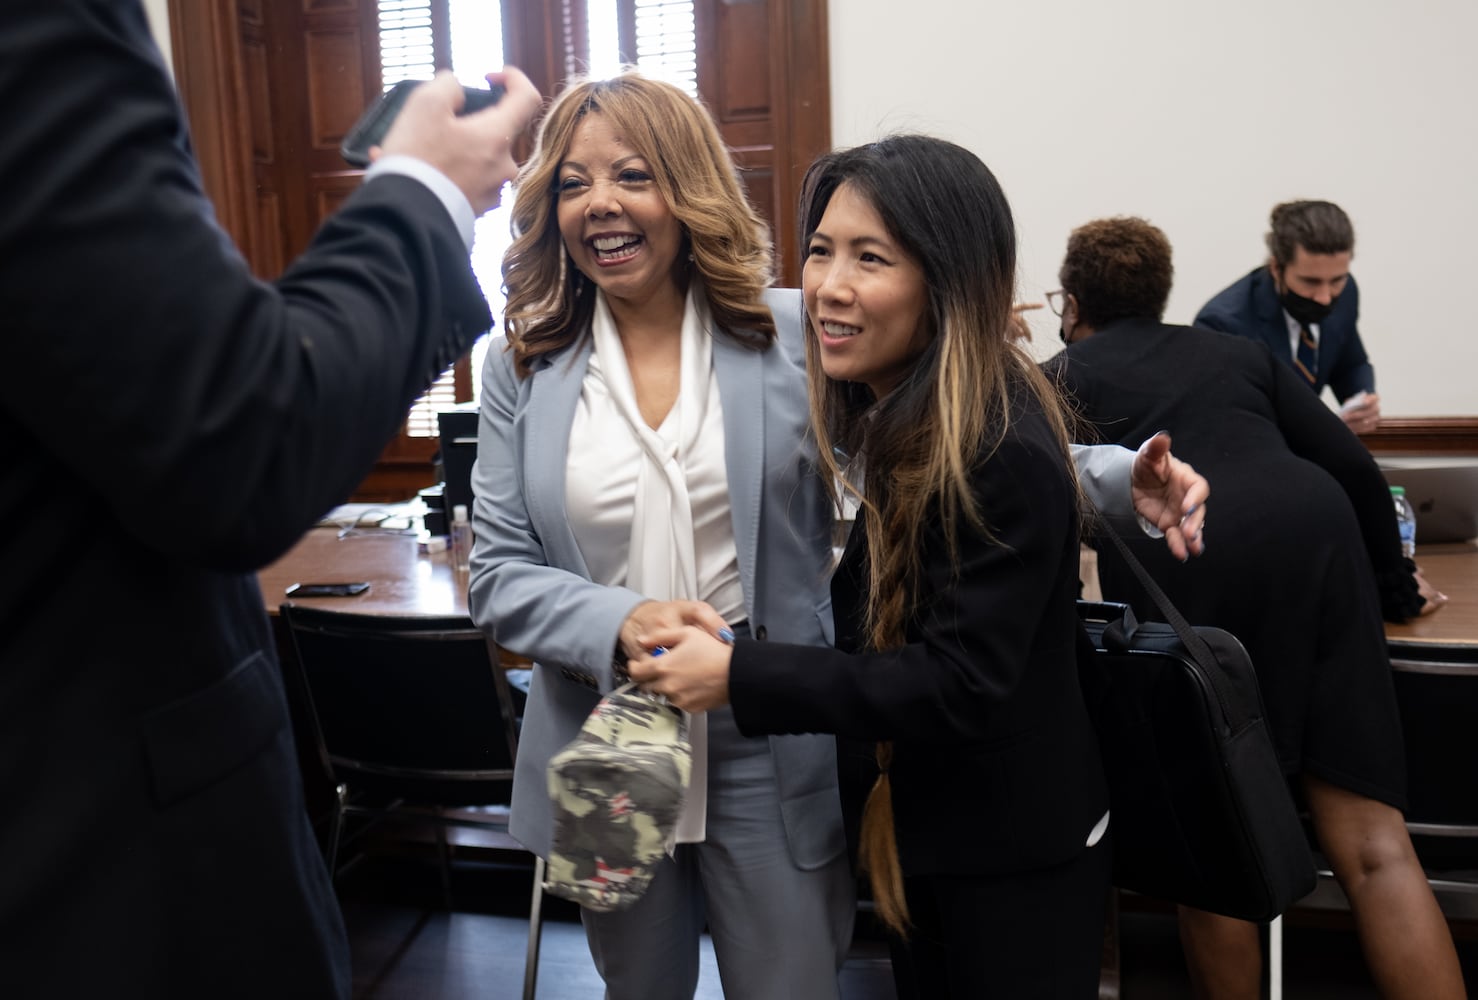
[1194,201,1380,434]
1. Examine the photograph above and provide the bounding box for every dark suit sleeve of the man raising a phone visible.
[0,0,489,569]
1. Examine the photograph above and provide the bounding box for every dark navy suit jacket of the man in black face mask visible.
[1193,264,1376,402]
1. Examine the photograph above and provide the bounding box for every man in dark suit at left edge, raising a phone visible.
[0,0,538,1000]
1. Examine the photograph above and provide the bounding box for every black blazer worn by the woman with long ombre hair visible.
[729,387,1109,876]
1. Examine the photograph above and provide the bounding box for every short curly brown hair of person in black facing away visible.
[1057,216,1175,326]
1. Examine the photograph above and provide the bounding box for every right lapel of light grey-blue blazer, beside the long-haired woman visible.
[714,334,779,616]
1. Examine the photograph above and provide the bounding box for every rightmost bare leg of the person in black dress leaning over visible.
[1304,774,1468,1000]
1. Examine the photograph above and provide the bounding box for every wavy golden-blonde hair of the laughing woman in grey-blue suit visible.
[503,71,776,377]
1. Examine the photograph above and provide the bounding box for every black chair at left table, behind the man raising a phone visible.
[281,604,544,1000]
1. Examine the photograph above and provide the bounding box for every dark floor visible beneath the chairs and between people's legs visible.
[340,857,1478,1000]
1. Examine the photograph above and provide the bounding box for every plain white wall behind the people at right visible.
[828,0,1478,417]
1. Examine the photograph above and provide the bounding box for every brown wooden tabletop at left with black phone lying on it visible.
[257,527,469,616]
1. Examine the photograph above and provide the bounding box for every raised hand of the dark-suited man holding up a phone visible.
[370,66,541,216]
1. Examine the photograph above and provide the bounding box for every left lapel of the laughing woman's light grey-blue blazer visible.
[523,337,591,579]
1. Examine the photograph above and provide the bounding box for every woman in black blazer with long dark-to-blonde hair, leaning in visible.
[630,136,1197,999]
